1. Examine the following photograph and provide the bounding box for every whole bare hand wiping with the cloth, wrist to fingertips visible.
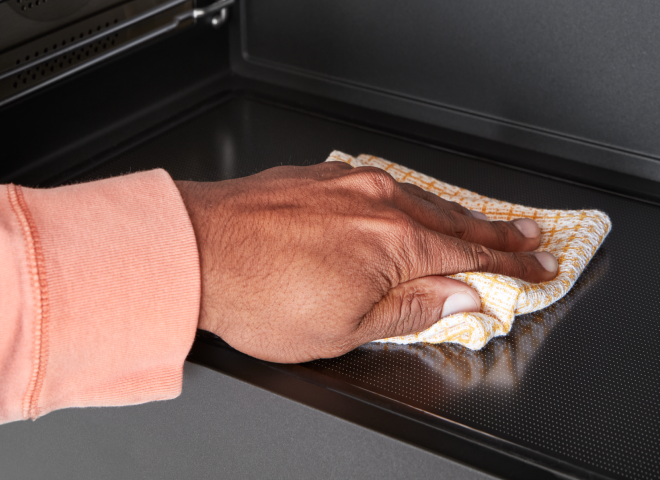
[176,162,557,363]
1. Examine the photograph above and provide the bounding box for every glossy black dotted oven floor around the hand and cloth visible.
[60,97,660,479]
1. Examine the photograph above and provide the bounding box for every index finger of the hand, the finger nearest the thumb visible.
[391,227,558,283]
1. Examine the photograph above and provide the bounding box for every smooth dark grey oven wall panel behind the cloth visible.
[234,0,660,180]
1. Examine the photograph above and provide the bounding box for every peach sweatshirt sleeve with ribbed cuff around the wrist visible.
[0,170,200,423]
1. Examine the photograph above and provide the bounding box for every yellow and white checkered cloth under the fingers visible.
[326,151,612,350]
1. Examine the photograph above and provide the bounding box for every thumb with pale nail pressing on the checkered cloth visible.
[360,276,481,343]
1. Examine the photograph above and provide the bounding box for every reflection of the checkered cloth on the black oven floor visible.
[310,250,608,403]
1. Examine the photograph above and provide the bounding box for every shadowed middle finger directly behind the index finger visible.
[395,184,541,252]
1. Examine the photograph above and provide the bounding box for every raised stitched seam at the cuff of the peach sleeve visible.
[7,185,49,419]
